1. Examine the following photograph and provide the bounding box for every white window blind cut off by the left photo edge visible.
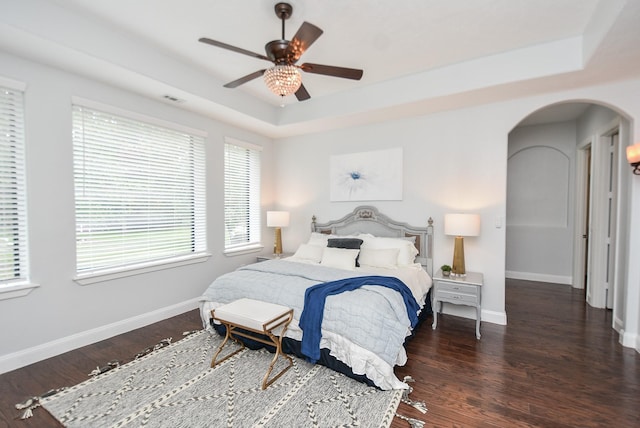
[0,87,28,286]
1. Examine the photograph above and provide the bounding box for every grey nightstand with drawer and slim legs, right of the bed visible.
[432,271,484,339]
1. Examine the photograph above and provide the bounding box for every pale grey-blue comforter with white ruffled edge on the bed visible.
[201,259,431,389]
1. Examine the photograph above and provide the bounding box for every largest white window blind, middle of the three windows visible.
[73,105,206,274]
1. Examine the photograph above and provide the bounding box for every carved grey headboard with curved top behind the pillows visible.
[311,205,433,276]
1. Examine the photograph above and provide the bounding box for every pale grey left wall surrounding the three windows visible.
[0,52,273,372]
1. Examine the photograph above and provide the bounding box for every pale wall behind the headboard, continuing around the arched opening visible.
[275,80,640,348]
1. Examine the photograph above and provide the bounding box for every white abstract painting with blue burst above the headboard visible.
[329,148,402,201]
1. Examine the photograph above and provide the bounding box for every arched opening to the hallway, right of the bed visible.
[506,102,629,329]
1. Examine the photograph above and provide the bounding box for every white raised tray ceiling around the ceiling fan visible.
[0,0,640,137]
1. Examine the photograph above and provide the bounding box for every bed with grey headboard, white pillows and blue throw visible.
[200,206,433,390]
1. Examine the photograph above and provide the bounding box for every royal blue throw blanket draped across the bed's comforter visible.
[299,276,420,363]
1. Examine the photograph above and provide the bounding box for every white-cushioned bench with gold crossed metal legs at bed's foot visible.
[211,299,293,389]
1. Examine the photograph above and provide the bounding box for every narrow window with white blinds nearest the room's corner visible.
[224,138,260,252]
